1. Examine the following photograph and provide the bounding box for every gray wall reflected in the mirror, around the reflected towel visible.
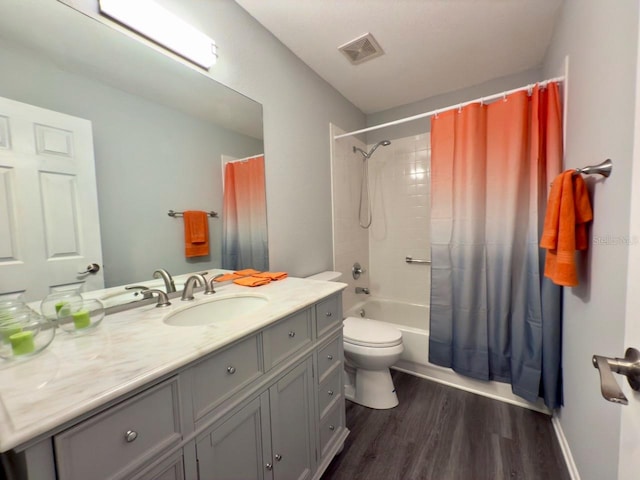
[0,42,263,286]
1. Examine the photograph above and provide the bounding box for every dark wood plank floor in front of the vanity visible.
[322,371,570,480]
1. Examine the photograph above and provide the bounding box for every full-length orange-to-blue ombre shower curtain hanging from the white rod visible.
[429,83,562,408]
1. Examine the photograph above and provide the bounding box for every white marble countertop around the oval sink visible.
[0,277,346,452]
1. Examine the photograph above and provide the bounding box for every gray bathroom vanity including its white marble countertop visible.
[0,278,349,480]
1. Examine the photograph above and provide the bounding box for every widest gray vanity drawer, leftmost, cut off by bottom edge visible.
[54,378,181,480]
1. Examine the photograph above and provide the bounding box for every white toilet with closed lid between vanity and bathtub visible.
[307,272,404,410]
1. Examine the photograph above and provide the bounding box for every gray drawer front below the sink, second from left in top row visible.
[193,335,264,420]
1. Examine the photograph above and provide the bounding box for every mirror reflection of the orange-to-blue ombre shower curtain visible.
[222,155,269,271]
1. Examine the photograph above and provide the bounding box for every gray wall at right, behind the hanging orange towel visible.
[544,0,638,480]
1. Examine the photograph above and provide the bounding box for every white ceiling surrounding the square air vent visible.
[236,0,563,113]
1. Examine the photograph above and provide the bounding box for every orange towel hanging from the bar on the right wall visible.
[540,170,593,287]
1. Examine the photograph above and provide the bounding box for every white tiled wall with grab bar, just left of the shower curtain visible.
[368,132,431,304]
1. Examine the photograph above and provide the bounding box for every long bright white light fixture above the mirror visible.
[100,0,218,70]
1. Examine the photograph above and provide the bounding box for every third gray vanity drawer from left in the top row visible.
[263,309,311,370]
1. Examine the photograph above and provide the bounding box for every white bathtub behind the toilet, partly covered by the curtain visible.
[344,297,551,414]
